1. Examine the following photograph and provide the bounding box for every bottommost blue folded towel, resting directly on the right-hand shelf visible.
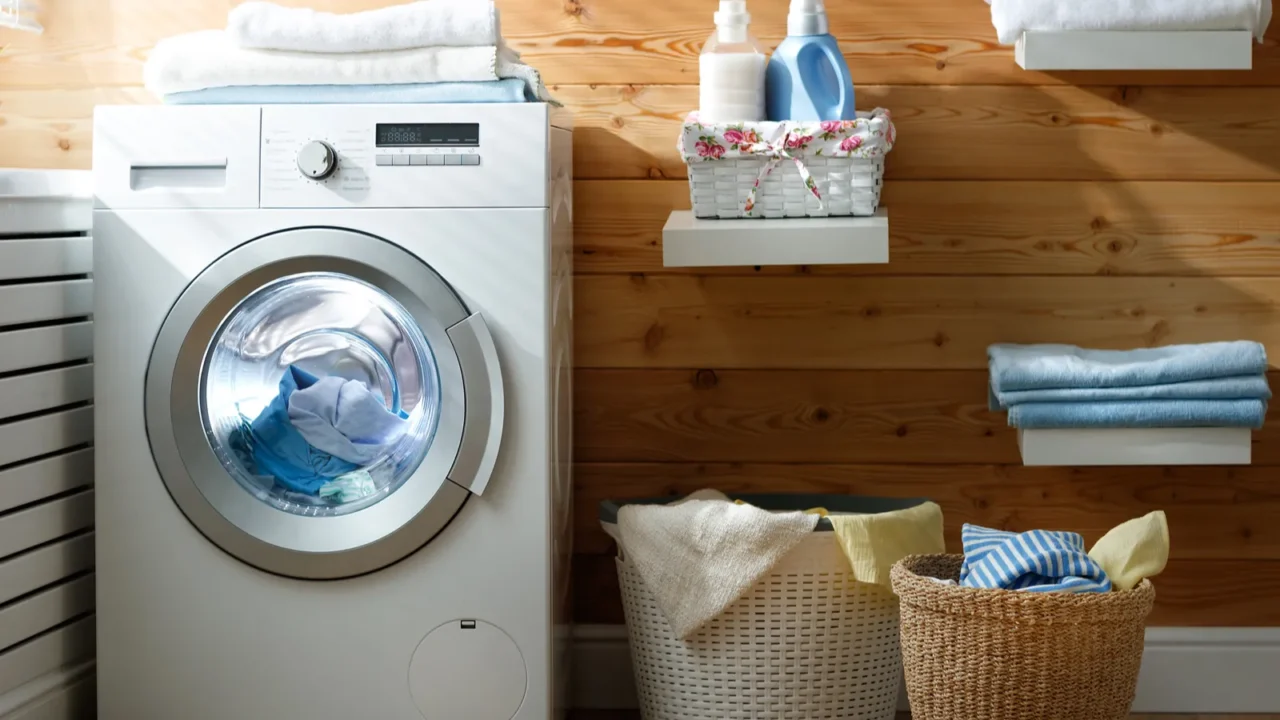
[1009,400,1267,429]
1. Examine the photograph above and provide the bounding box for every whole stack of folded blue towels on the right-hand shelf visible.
[987,341,1271,429]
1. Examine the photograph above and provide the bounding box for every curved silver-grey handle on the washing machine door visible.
[448,313,506,495]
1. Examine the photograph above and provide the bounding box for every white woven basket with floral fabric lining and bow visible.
[678,109,895,218]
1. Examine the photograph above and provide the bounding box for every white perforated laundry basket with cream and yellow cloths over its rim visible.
[606,507,902,720]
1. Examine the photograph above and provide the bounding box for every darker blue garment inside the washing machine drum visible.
[250,365,360,495]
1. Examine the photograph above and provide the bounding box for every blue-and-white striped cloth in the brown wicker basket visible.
[960,524,1111,592]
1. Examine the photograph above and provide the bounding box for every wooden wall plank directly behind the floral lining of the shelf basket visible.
[557,86,1280,181]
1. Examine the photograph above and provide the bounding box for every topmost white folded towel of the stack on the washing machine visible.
[227,0,502,53]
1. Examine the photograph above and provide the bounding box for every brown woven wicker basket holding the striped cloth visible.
[892,555,1156,720]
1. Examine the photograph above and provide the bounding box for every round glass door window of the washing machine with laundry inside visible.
[201,273,440,516]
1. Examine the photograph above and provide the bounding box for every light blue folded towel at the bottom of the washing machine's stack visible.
[164,78,538,105]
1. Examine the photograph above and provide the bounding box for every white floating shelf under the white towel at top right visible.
[1014,29,1253,70]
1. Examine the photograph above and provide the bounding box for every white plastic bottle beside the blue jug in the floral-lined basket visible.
[698,0,765,123]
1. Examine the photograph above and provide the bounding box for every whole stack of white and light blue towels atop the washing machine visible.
[143,0,554,104]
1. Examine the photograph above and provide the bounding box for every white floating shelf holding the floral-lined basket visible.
[662,208,888,268]
